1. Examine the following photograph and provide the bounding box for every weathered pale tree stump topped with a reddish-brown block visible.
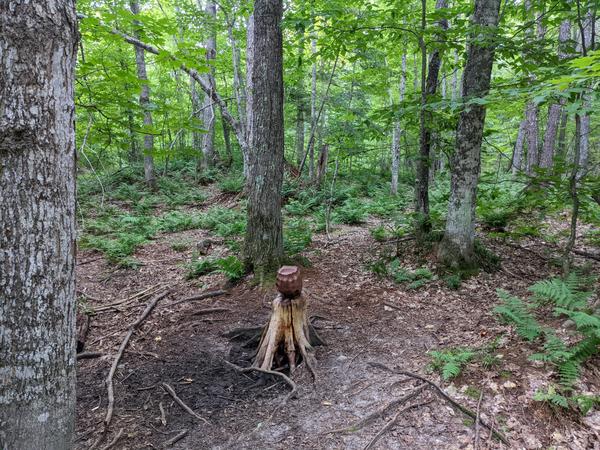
[253,266,323,378]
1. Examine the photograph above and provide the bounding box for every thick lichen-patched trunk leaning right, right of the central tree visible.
[438,0,500,267]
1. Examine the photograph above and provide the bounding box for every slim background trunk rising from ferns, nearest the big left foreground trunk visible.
[129,0,156,189]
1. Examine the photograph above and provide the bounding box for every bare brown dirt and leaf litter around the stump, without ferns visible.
[76,204,600,449]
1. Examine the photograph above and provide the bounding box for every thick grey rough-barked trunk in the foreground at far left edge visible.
[0,0,78,450]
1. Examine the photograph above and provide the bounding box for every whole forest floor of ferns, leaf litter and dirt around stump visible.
[78,165,600,448]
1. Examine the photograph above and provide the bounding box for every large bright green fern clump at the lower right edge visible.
[494,273,600,412]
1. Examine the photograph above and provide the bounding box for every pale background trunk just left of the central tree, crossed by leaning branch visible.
[199,0,217,170]
